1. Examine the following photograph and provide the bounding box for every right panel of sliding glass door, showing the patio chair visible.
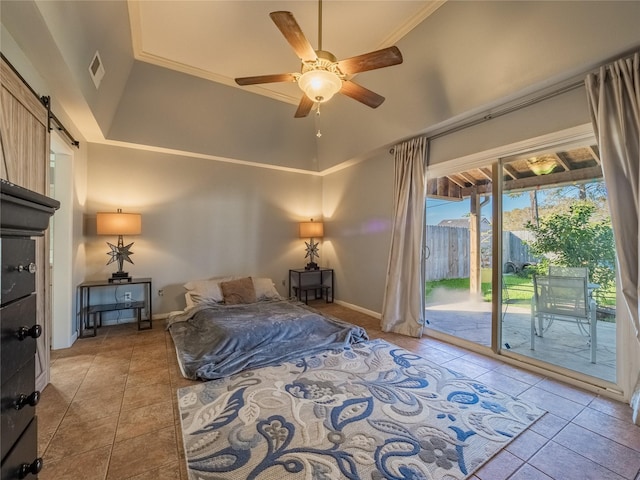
[500,146,616,383]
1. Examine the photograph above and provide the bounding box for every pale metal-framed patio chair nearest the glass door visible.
[531,275,597,363]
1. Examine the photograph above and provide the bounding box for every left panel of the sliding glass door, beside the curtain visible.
[425,165,493,347]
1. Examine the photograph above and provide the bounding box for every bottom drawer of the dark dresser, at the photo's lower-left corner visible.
[0,417,42,480]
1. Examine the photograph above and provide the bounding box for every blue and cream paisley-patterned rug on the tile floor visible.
[178,340,544,480]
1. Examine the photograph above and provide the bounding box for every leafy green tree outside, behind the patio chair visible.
[526,200,615,291]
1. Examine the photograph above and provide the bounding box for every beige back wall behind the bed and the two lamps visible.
[85,144,322,315]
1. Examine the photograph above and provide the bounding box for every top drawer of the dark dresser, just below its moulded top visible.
[0,238,36,305]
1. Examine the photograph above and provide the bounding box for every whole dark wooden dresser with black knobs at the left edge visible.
[0,180,60,480]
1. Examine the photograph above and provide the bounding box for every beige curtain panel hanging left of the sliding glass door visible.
[381,137,428,337]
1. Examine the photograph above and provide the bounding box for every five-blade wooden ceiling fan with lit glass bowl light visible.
[235,0,402,118]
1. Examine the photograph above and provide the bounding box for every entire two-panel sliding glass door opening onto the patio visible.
[425,145,616,383]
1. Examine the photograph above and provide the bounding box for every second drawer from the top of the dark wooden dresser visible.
[0,294,41,380]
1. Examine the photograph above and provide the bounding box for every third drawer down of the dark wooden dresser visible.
[0,357,40,458]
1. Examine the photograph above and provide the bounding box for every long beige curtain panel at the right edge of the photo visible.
[585,49,640,424]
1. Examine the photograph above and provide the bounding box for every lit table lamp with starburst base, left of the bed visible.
[96,208,142,283]
